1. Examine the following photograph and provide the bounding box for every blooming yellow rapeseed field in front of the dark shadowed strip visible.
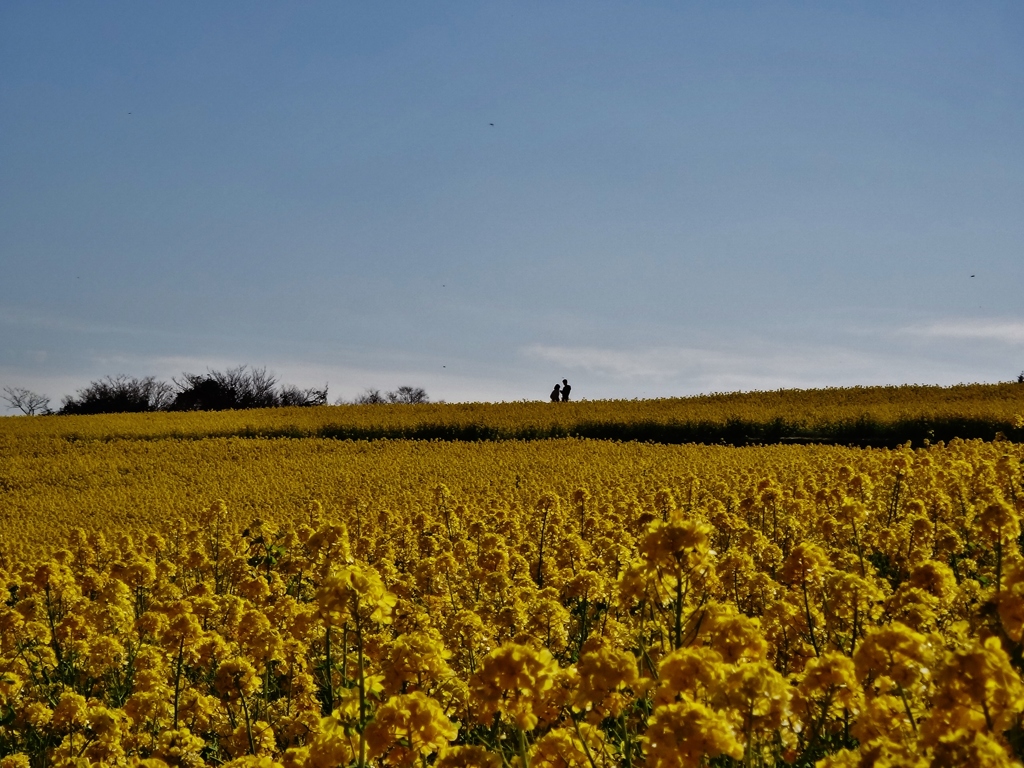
[0,428,1024,768]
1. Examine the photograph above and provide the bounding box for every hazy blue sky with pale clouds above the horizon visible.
[0,0,1024,409]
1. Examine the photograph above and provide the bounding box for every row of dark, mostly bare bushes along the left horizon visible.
[0,366,429,416]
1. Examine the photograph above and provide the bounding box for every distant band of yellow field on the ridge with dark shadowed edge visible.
[0,384,1024,446]
